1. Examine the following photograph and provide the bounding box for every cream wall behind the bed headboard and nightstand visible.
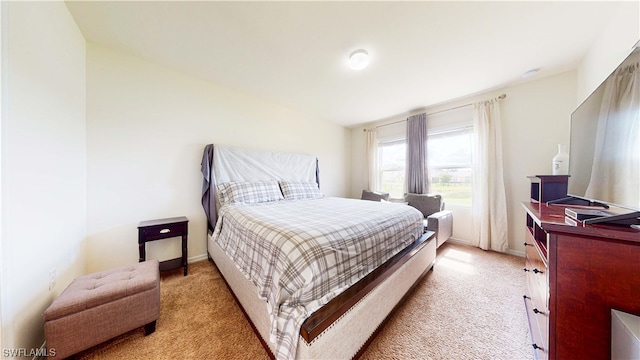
[87,43,350,271]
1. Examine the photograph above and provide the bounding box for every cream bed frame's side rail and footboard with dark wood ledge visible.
[207,231,436,359]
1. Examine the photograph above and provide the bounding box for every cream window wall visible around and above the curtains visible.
[350,72,576,254]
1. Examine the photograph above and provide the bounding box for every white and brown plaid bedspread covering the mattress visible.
[213,198,423,359]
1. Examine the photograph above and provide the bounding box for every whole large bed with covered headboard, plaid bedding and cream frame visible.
[202,145,436,359]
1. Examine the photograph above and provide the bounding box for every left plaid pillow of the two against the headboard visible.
[217,180,284,205]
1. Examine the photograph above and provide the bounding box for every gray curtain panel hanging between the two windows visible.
[407,113,429,194]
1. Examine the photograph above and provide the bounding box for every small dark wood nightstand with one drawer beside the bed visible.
[138,216,189,276]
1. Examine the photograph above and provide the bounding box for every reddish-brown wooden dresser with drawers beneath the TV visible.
[523,202,640,359]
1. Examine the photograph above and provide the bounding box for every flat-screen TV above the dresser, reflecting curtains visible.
[568,48,640,222]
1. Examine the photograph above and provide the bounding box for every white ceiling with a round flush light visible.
[67,1,620,126]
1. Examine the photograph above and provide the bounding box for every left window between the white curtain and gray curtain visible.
[378,139,407,199]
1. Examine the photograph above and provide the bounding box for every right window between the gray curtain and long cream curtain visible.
[427,127,473,206]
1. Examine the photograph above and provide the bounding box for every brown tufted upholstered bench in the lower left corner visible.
[44,260,160,358]
